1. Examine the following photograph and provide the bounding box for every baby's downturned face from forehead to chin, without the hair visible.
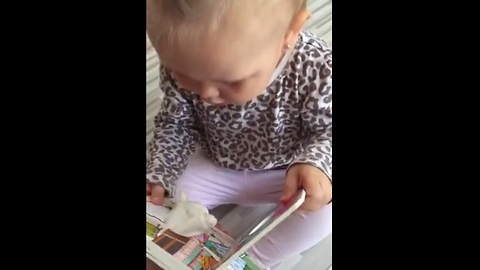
[154,27,284,105]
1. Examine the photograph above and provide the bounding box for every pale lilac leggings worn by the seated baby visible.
[176,152,332,267]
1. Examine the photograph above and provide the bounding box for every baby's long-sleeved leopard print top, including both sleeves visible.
[147,32,332,196]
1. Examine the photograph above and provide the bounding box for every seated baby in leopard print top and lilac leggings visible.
[146,0,332,267]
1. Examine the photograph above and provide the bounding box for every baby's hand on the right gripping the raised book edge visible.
[280,164,332,211]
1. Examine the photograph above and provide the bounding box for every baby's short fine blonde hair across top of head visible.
[147,0,306,54]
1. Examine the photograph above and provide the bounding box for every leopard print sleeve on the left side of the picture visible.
[147,66,198,196]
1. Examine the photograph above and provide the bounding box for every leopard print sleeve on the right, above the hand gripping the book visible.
[292,43,332,180]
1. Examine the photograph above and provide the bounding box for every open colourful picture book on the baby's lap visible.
[147,190,305,270]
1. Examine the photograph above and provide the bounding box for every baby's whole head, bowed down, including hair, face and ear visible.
[147,0,309,104]
